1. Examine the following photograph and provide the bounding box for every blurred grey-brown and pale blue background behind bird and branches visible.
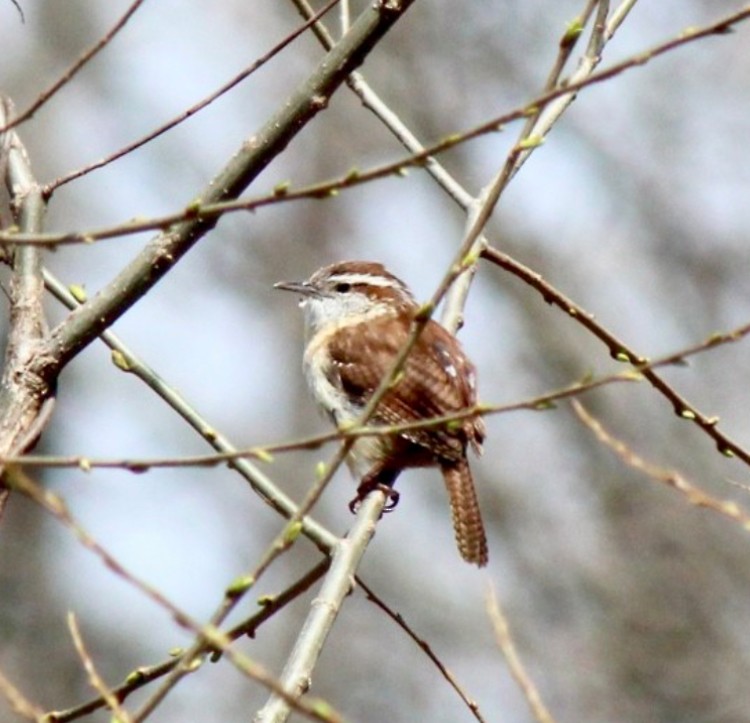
[0,0,750,723]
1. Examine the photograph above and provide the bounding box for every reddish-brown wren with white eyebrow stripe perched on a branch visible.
[275,261,487,567]
